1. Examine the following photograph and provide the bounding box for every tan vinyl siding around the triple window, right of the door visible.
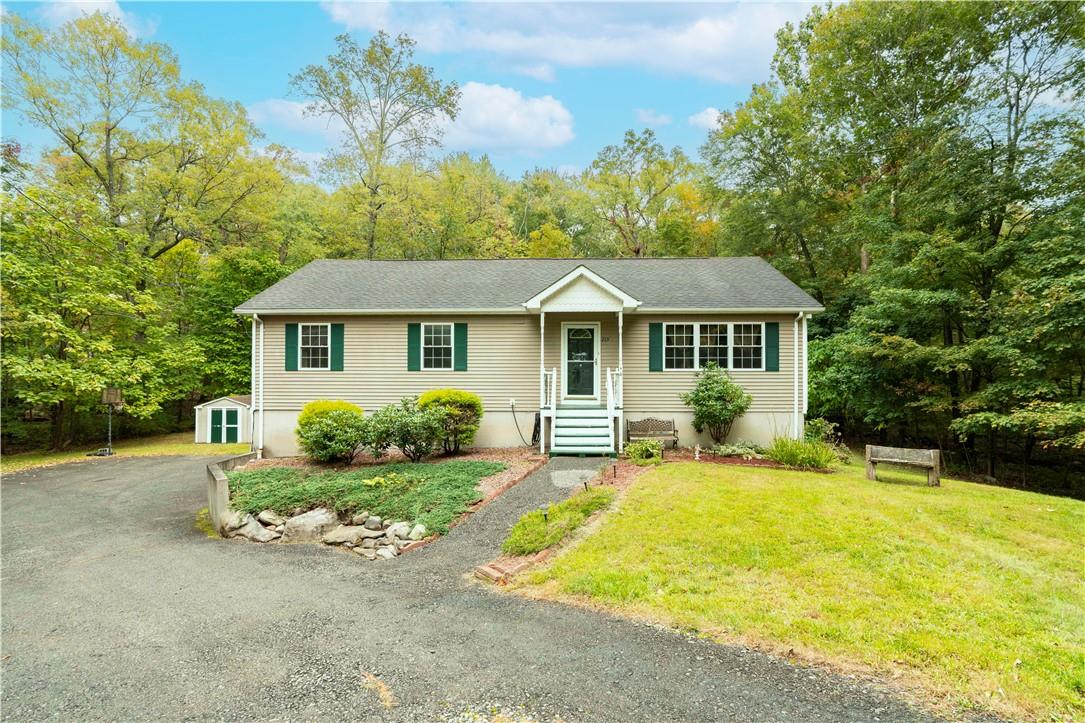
[624,314,794,413]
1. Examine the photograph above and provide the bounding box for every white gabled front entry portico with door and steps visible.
[524,266,640,454]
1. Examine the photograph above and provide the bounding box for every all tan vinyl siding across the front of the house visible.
[264,313,802,414]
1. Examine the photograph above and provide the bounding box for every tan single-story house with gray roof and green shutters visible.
[234,257,822,456]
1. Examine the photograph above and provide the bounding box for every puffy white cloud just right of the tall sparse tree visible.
[445,80,574,153]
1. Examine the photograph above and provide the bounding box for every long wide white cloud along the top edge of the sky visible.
[323,0,812,83]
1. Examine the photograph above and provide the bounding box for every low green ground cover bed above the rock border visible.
[227,461,505,534]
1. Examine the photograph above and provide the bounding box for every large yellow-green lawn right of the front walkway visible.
[524,464,1085,720]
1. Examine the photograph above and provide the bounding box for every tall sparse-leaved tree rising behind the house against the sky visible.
[290,30,460,258]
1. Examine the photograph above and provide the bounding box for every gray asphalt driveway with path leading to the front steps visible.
[0,458,926,721]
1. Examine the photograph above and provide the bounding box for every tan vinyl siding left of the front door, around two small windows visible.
[264,314,539,411]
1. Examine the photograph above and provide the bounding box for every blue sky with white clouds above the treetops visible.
[3,0,809,177]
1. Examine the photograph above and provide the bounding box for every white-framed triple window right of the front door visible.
[663,321,765,371]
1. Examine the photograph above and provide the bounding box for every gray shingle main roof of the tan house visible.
[235,256,821,314]
